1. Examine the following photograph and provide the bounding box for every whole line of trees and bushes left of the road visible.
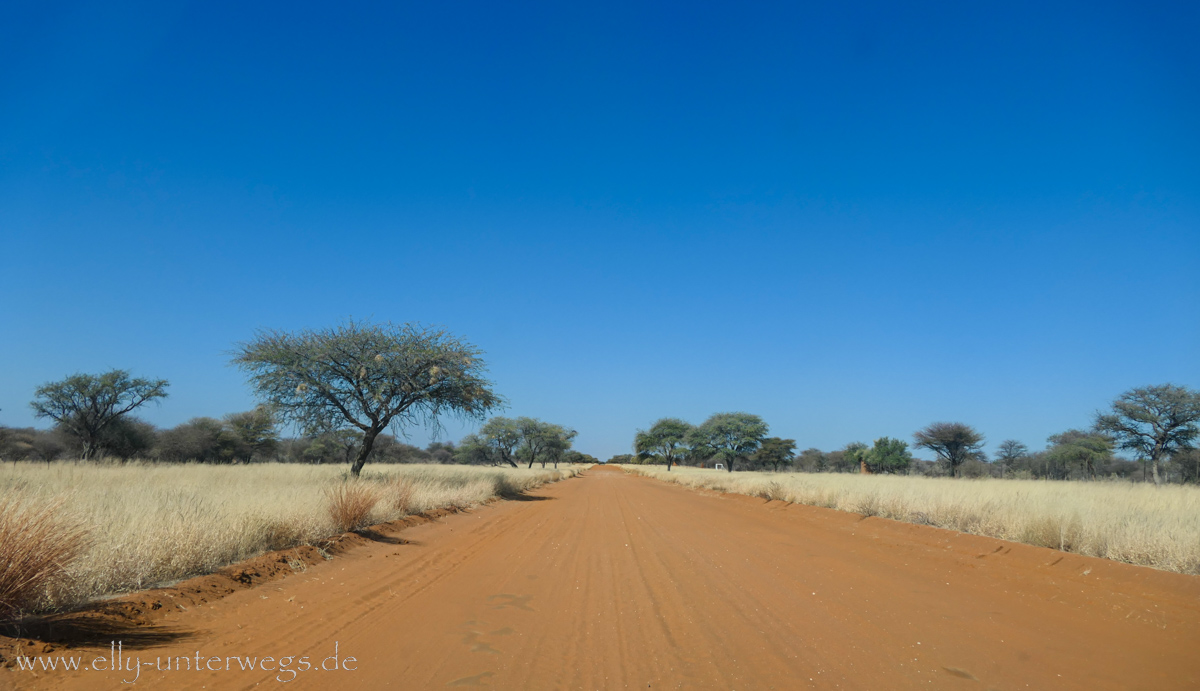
[0,320,599,474]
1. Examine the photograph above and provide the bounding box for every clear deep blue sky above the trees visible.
[0,0,1200,457]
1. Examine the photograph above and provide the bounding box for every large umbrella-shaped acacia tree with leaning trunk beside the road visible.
[233,319,502,475]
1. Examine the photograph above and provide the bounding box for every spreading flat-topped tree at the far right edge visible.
[1094,384,1200,485]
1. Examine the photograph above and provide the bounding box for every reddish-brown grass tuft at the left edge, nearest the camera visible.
[0,489,88,620]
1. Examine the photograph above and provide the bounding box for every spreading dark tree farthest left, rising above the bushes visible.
[30,369,168,458]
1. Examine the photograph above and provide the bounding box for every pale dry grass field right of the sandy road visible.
[625,465,1200,573]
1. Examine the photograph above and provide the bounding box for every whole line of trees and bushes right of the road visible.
[624,384,1200,483]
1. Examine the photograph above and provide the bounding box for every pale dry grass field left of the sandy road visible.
[0,463,580,609]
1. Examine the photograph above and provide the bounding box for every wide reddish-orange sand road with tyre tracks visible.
[7,469,1200,690]
